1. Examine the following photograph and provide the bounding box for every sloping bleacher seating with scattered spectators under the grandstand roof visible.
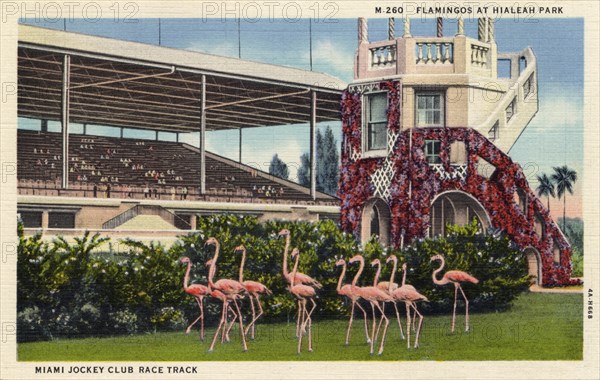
[17,130,335,202]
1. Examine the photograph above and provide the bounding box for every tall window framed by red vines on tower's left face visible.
[363,92,388,151]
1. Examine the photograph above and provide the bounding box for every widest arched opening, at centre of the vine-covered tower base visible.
[429,190,491,237]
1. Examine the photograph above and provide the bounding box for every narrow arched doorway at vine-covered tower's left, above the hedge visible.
[360,198,391,247]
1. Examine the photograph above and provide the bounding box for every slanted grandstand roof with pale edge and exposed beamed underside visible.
[18,25,347,132]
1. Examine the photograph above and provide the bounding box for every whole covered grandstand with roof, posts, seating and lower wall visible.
[17,25,346,238]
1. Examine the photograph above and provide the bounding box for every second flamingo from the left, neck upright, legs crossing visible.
[205,237,248,352]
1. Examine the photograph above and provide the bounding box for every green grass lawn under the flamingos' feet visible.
[18,293,583,361]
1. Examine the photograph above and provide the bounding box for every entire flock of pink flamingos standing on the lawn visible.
[181,229,479,354]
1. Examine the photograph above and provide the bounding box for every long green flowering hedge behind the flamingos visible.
[17,215,529,341]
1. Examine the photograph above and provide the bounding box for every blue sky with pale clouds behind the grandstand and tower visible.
[22,19,584,214]
